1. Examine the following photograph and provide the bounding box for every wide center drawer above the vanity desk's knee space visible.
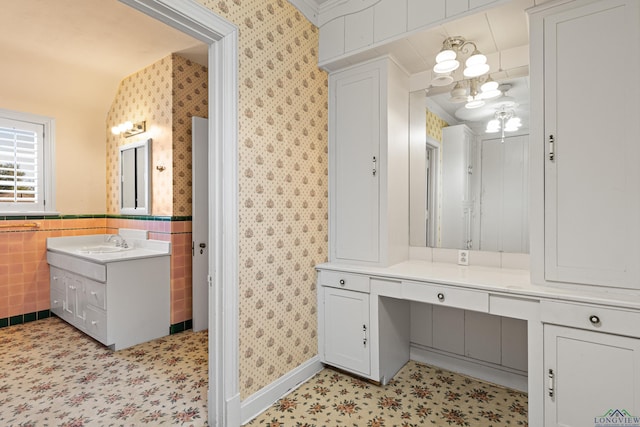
[402,282,489,313]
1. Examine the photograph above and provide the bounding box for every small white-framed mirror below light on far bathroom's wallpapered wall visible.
[120,139,151,215]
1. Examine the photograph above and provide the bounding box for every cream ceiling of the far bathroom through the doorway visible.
[0,0,207,113]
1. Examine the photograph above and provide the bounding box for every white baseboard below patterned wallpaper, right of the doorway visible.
[240,356,324,424]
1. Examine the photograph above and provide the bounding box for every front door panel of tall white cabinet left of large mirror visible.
[329,69,381,262]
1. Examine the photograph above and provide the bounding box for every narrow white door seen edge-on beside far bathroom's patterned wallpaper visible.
[191,117,209,332]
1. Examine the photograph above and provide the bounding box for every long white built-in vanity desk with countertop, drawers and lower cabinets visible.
[317,260,640,426]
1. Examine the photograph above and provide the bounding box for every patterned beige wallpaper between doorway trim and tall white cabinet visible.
[199,0,328,399]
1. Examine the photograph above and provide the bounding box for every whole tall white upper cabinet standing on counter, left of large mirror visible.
[329,58,409,266]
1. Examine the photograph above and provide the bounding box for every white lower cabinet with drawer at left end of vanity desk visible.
[318,270,410,384]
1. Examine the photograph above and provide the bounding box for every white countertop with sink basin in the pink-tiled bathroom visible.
[47,234,171,264]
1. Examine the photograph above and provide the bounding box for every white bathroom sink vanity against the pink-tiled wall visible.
[47,232,171,350]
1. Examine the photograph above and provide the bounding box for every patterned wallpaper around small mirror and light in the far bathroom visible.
[106,54,208,216]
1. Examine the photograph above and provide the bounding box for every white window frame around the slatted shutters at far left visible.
[0,108,58,216]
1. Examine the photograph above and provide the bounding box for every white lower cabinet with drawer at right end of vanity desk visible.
[541,302,640,426]
